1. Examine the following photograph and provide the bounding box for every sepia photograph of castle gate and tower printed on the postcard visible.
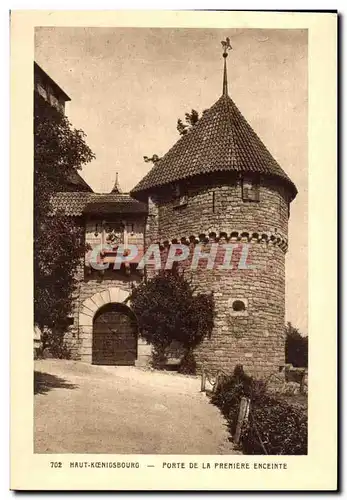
[33,27,308,458]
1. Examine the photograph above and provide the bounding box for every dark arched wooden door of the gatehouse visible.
[92,304,137,365]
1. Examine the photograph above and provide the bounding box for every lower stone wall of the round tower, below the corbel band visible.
[191,243,285,376]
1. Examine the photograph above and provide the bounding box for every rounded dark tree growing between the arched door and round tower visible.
[130,267,214,372]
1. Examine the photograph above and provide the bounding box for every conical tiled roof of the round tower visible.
[131,92,297,199]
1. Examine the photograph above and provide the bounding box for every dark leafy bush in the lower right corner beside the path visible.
[212,367,307,455]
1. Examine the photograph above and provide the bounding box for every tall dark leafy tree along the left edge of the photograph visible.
[34,96,94,352]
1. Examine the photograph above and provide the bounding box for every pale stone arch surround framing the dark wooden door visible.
[78,287,129,363]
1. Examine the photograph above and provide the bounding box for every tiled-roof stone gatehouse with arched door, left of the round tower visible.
[52,179,151,365]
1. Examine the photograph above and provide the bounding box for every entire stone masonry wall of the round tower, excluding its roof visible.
[148,175,289,377]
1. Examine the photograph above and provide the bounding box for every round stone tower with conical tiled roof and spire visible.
[131,45,297,376]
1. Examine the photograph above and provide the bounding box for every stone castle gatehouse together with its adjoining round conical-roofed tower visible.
[40,46,297,376]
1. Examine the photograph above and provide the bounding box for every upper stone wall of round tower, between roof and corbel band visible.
[158,175,288,240]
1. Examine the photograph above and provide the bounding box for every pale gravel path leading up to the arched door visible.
[34,359,237,455]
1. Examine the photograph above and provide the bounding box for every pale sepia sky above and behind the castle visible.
[35,27,308,334]
